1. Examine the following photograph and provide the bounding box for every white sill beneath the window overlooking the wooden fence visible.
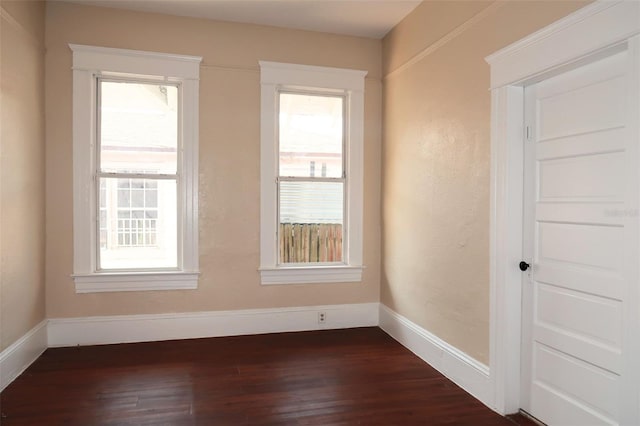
[260,265,364,285]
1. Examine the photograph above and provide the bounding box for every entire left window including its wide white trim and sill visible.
[70,45,201,292]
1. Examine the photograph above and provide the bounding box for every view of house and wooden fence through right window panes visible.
[277,91,346,264]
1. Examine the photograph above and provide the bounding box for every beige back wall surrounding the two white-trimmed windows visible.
[46,2,382,318]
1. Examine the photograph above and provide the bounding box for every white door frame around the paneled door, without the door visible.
[486,0,640,414]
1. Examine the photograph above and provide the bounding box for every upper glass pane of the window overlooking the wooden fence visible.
[279,93,344,177]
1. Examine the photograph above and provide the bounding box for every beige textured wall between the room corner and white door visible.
[381,1,587,364]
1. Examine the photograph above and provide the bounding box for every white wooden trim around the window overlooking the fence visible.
[259,61,367,285]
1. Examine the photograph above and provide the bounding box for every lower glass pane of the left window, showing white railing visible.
[99,178,178,270]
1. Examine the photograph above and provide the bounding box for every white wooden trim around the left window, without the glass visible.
[69,44,202,293]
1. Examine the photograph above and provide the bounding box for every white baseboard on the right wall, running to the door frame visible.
[379,304,495,409]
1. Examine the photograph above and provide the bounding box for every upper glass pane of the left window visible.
[100,81,178,174]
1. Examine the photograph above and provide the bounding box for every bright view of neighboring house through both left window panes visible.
[96,79,179,270]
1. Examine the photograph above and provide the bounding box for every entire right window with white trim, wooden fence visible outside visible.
[260,62,366,284]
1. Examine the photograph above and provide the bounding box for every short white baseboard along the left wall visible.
[0,320,47,392]
